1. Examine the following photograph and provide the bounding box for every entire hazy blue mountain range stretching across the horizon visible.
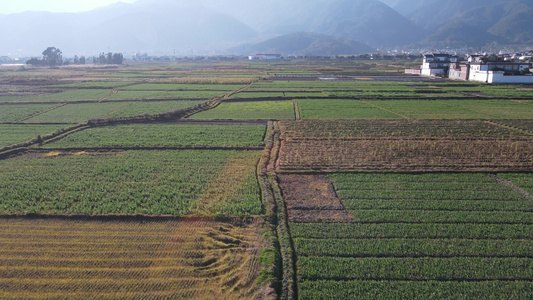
[0,0,533,56]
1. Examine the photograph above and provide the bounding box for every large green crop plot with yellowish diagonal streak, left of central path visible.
[0,150,262,216]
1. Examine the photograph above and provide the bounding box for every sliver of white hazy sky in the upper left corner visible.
[0,0,136,14]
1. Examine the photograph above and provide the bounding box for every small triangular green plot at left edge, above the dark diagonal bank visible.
[0,124,64,148]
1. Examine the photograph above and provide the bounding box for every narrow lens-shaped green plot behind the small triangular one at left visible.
[24,102,132,123]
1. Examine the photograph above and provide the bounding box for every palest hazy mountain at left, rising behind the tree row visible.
[0,1,256,55]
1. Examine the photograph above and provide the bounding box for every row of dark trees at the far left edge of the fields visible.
[26,47,124,67]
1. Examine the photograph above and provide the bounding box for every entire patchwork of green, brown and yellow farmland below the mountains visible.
[0,57,533,300]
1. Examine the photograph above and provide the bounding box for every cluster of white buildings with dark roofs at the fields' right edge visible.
[405,54,533,83]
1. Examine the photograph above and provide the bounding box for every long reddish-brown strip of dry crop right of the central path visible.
[279,137,533,172]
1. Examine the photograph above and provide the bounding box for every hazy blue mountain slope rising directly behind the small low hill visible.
[199,0,424,47]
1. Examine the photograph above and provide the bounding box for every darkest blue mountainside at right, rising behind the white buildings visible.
[399,0,533,47]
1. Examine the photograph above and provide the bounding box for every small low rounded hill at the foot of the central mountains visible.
[241,32,376,55]
